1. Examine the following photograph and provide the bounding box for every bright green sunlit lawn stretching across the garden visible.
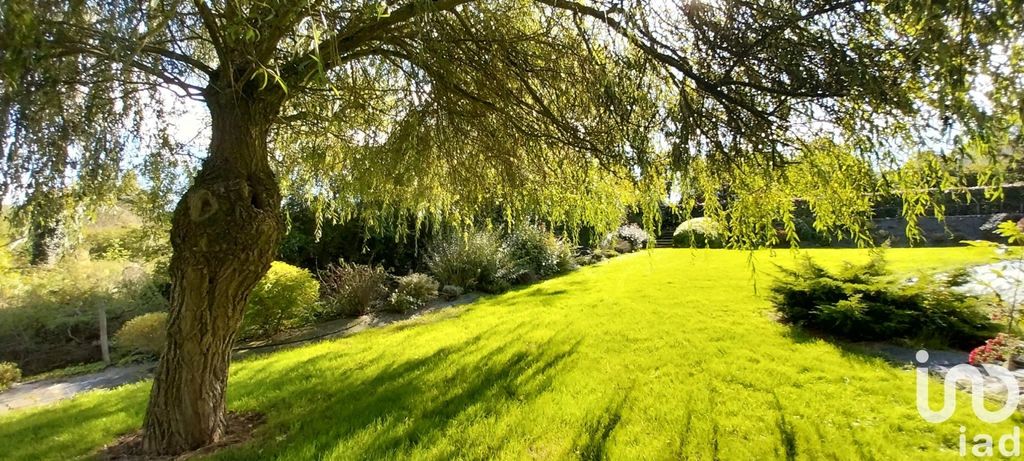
[0,248,1021,460]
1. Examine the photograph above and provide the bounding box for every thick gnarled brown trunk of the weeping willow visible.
[143,89,283,455]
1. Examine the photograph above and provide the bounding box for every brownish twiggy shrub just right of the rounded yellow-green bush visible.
[319,262,389,318]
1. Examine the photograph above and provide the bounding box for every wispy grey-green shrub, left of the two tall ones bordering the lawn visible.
[427,231,512,293]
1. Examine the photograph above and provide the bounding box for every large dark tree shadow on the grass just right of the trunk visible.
[221,328,581,459]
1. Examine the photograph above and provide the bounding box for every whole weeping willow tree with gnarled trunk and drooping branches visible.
[0,0,1022,454]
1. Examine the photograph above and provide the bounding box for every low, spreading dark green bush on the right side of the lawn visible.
[771,254,996,347]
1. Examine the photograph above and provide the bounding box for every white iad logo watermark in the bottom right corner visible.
[915,350,1021,457]
